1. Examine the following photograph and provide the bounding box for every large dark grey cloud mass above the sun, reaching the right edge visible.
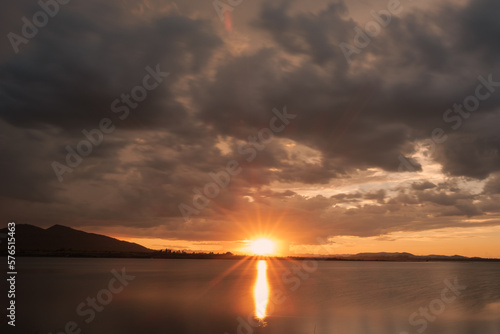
[198,2,500,183]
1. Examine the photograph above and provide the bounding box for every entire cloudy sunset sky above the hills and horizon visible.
[0,0,500,257]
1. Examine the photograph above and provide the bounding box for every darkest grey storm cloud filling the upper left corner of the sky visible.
[0,4,221,131]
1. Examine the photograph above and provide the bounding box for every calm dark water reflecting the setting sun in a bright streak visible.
[2,258,500,334]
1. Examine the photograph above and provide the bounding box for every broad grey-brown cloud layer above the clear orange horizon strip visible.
[0,0,500,241]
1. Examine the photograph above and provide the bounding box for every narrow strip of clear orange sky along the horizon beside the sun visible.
[115,227,500,258]
